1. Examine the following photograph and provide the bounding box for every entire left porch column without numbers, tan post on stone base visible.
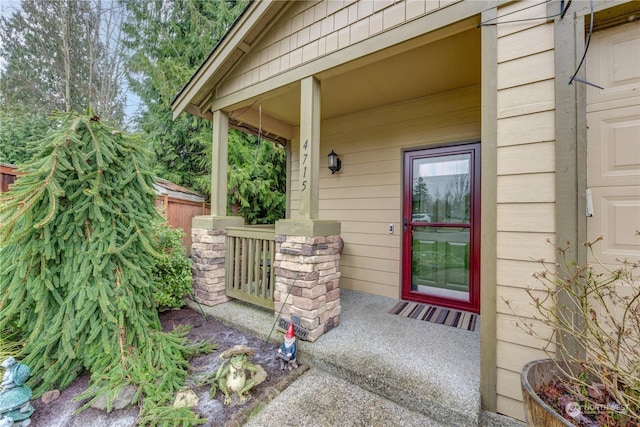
[191,110,244,306]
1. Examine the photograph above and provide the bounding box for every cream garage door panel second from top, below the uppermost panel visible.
[587,105,640,186]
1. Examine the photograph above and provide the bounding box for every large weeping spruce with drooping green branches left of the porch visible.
[0,114,209,425]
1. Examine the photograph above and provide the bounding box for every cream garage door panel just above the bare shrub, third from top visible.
[587,186,640,264]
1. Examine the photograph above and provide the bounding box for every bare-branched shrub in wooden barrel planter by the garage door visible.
[506,237,640,427]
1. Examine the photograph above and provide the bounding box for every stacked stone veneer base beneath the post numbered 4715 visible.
[274,234,342,341]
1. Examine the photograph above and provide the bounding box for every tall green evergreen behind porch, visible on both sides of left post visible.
[125,0,286,224]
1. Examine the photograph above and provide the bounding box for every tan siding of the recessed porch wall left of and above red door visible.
[291,86,480,298]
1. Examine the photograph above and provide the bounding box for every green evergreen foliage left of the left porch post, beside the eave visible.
[123,0,248,197]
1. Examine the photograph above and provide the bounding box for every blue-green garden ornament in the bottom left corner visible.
[0,357,34,427]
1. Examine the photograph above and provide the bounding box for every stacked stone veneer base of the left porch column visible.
[191,228,232,306]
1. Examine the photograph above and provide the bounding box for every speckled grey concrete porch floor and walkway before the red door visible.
[189,289,524,427]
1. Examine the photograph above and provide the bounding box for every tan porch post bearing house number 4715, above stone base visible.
[298,76,320,219]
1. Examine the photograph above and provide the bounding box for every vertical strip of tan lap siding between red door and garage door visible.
[496,1,556,419]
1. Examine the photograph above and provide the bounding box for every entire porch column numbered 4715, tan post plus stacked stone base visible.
[274,76,342,341]
